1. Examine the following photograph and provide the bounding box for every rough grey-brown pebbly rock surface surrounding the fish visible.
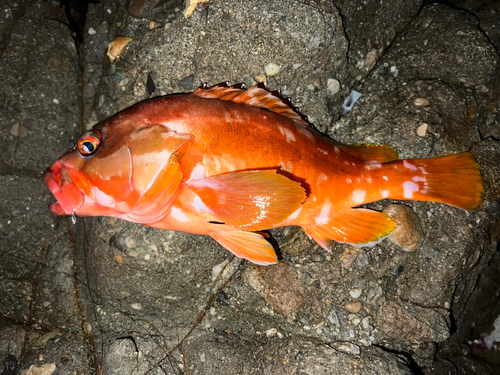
[0,0,500,374]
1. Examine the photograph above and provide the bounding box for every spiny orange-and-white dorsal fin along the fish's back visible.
[193,83,309,127]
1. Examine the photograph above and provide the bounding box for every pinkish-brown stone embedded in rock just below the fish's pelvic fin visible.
[245,262,304,314]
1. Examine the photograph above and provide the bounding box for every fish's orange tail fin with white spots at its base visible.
[387,152,484,210]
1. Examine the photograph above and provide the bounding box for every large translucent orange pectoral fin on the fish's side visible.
[187,170,306,231]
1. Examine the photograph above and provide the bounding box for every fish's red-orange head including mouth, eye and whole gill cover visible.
[44,115,192,223]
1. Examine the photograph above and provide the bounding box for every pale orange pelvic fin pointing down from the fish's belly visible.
[210,230,278,266]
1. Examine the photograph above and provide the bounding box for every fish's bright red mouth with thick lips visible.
[43,161,84,215]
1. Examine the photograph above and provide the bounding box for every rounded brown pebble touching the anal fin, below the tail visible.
[384,204,424,251]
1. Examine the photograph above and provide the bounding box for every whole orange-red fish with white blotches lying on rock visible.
[44,84,483,265]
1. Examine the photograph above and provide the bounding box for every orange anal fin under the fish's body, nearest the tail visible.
[304,208,396,250]
